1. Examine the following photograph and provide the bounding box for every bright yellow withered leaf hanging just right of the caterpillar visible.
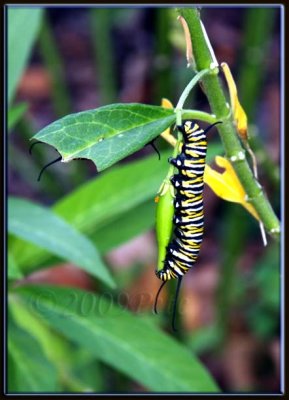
[204,156,260,221]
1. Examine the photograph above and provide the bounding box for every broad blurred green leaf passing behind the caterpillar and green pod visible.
[13,144,222,271]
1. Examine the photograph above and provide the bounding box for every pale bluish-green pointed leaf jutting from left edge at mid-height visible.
[8,197,115,287]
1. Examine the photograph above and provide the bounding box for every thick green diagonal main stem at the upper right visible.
[178,8,280,239]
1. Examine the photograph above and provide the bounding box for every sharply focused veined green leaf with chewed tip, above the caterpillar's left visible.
[34,103,175,171]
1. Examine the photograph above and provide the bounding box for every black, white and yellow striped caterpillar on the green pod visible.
[154,120,220,330]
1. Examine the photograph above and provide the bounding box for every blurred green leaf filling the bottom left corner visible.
[8,319,59,394]
